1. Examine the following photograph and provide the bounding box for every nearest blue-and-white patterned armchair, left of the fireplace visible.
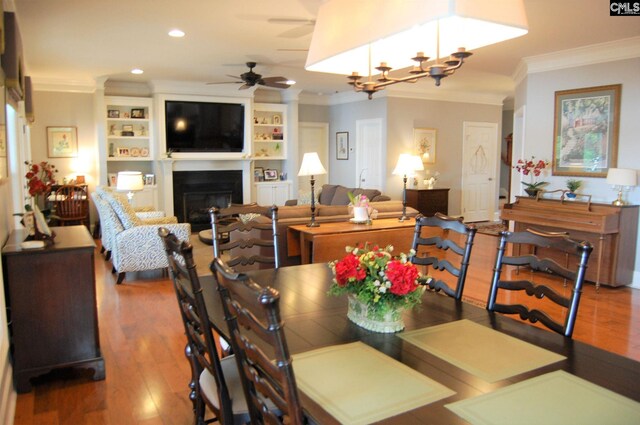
[94,188,191,284]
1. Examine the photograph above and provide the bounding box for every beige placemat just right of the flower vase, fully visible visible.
[398,320,565,382]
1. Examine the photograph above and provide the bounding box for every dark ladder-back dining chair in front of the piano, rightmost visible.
[487,229,593,338]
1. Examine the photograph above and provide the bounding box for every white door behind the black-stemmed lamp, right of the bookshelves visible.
[292,122,329,199]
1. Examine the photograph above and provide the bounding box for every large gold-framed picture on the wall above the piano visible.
[551,84,622,177]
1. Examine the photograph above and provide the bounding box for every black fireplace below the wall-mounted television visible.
[173,170,243,232]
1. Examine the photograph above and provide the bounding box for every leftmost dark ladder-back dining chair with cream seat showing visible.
[158,227,249,425]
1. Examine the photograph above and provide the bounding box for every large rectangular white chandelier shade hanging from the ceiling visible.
[305,0,528,75]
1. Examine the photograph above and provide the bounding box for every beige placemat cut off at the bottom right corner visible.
[446,370,640,425]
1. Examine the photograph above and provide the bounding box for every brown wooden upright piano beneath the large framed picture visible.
[500,197,638,286]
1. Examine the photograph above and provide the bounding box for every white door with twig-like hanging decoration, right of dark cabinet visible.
[462,122,500,222]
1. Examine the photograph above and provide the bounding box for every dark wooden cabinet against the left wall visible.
[2,226,105,393]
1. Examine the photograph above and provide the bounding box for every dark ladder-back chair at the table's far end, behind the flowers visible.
[209,204,280,271]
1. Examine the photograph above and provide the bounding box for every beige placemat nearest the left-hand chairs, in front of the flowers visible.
[293,342,455,424]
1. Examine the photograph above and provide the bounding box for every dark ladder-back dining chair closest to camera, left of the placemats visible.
[211,258,304,425]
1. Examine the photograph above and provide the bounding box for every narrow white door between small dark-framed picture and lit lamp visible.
[355,118,386,188]
